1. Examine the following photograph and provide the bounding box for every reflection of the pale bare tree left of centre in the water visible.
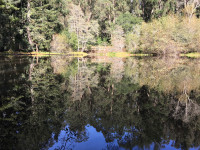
[70,58,98,101]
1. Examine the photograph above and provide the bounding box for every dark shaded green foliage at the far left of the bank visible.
[0,0,26,51]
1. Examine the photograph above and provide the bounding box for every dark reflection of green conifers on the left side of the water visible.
[0,57,67,149]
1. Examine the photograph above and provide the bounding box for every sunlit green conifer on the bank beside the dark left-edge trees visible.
[27,0,61,51]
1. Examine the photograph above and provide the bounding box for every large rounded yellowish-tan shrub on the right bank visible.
[132,15,200,55]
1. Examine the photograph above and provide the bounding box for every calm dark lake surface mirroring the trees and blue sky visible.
[0,56,200,150]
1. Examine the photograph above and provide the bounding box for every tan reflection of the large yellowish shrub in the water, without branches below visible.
[126,58,200,93]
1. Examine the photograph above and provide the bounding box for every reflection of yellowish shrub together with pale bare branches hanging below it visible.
[125,57,200,122]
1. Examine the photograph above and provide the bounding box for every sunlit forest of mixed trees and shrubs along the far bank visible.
[0,0,200,55]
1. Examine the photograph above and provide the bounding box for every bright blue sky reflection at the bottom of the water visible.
[49,125,186,150]
